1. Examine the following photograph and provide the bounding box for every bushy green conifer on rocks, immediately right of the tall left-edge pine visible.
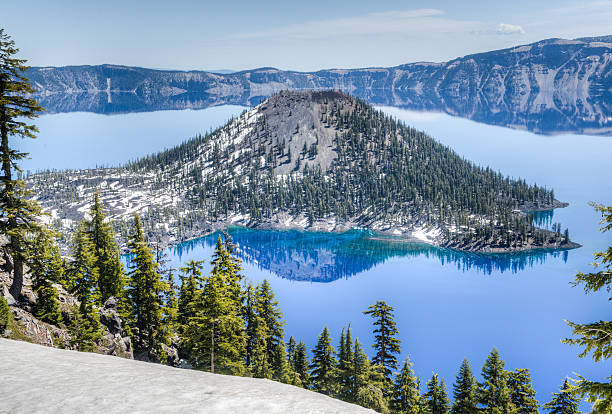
[27,232,64,325]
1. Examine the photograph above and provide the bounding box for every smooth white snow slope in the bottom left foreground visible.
[0,339,372,414]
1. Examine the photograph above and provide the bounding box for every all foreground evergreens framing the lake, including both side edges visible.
[0,29,612,413]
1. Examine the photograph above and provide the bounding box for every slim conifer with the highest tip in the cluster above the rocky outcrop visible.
[88,192,125,305]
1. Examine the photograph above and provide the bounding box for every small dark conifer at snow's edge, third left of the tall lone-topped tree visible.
[310,326,337,395]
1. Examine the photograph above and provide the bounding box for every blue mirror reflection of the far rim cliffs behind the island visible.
[36,85,612,135]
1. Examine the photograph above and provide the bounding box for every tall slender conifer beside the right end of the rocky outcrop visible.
[128,214,168,361]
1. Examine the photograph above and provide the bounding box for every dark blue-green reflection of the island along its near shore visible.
[172,227,568,282]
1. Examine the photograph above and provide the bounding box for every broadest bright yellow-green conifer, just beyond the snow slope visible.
[186,237,246,375]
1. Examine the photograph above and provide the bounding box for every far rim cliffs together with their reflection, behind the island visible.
[28,36,612,134]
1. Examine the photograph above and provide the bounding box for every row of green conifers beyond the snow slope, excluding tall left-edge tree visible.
[8,192,579,413]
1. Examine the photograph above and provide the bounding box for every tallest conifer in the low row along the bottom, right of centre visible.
[478,348,513,414]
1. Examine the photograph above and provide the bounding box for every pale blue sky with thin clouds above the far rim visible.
[0,0,612,71]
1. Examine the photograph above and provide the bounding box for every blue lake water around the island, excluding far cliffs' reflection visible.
[22,106,612,408]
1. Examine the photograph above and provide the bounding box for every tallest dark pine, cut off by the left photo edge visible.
[0,29,42,299]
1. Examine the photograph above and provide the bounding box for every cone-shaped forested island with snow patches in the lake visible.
[29,91,577,252]
